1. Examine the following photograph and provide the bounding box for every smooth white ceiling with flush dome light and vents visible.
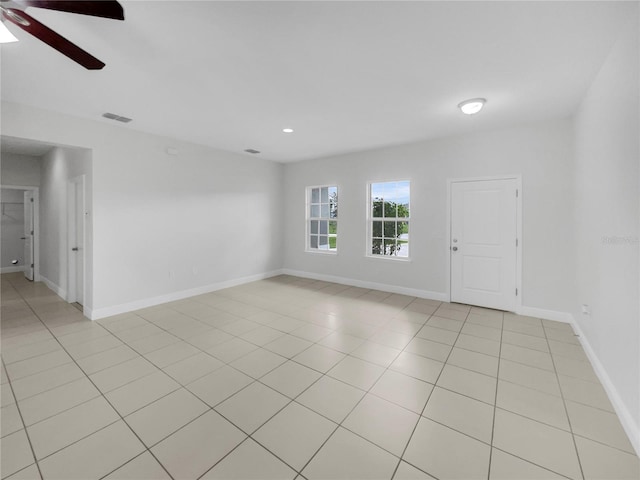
[2,1,637,162]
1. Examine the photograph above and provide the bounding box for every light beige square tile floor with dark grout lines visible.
[2,274,640,480]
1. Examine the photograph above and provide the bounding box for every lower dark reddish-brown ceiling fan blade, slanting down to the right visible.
[2,8,105,70]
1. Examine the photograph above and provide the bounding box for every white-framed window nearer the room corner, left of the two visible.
[307,186,338,252]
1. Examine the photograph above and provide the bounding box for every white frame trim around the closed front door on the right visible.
[445,174,524,313]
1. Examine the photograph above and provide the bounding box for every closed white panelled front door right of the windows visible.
[450,179,518,311]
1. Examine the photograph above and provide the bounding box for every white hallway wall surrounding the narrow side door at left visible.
[40,147,93,308]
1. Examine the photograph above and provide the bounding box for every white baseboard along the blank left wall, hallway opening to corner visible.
[90,270,282,320]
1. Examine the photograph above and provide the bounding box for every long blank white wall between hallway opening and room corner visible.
[2,102,283,316]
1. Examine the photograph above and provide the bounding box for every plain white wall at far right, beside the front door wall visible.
[571,11,640,451]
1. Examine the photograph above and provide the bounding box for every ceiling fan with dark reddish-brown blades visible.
[0,0,124,70]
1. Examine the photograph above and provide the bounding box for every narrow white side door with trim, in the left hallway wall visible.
[67,175,86,305]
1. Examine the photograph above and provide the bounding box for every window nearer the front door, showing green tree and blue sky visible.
[368,181,410,258]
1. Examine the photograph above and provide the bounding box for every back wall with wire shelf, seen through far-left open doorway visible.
[0,188,25,272]
